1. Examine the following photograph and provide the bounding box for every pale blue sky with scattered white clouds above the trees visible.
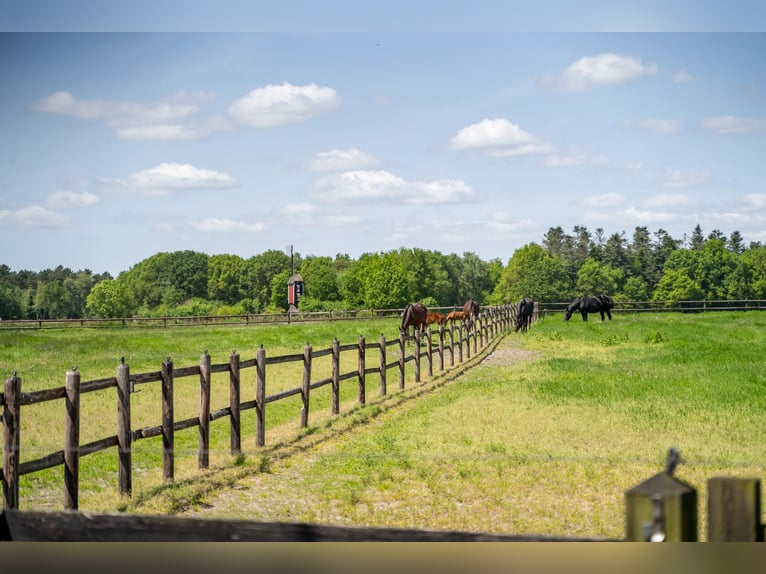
[0,0,766,277]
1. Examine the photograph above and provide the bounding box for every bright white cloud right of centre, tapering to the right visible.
[450,118,554,157]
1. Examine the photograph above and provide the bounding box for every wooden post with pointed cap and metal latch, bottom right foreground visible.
[625,449,697,542]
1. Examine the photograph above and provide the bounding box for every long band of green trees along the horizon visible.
[0,224,766,319]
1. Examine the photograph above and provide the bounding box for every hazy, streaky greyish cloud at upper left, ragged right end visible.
[30,91,212,140]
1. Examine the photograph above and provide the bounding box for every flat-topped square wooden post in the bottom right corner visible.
[707,477,763,542]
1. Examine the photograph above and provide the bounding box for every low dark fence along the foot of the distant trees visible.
[0,299,766,330]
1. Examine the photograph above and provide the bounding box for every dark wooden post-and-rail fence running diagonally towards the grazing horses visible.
[0,305,515,510]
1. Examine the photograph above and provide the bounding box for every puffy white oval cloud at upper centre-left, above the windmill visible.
[229,82,340,128]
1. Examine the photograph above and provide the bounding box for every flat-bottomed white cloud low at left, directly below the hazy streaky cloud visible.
[127,163,237,194]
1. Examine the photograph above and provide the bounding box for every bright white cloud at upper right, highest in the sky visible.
[560,54,657,92]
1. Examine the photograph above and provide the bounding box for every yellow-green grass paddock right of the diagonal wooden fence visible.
[182,312,766,540]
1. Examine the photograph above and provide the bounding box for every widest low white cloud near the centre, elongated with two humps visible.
[314,170,474,204]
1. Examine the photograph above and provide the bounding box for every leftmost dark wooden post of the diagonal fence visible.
[3,371,21,509]
